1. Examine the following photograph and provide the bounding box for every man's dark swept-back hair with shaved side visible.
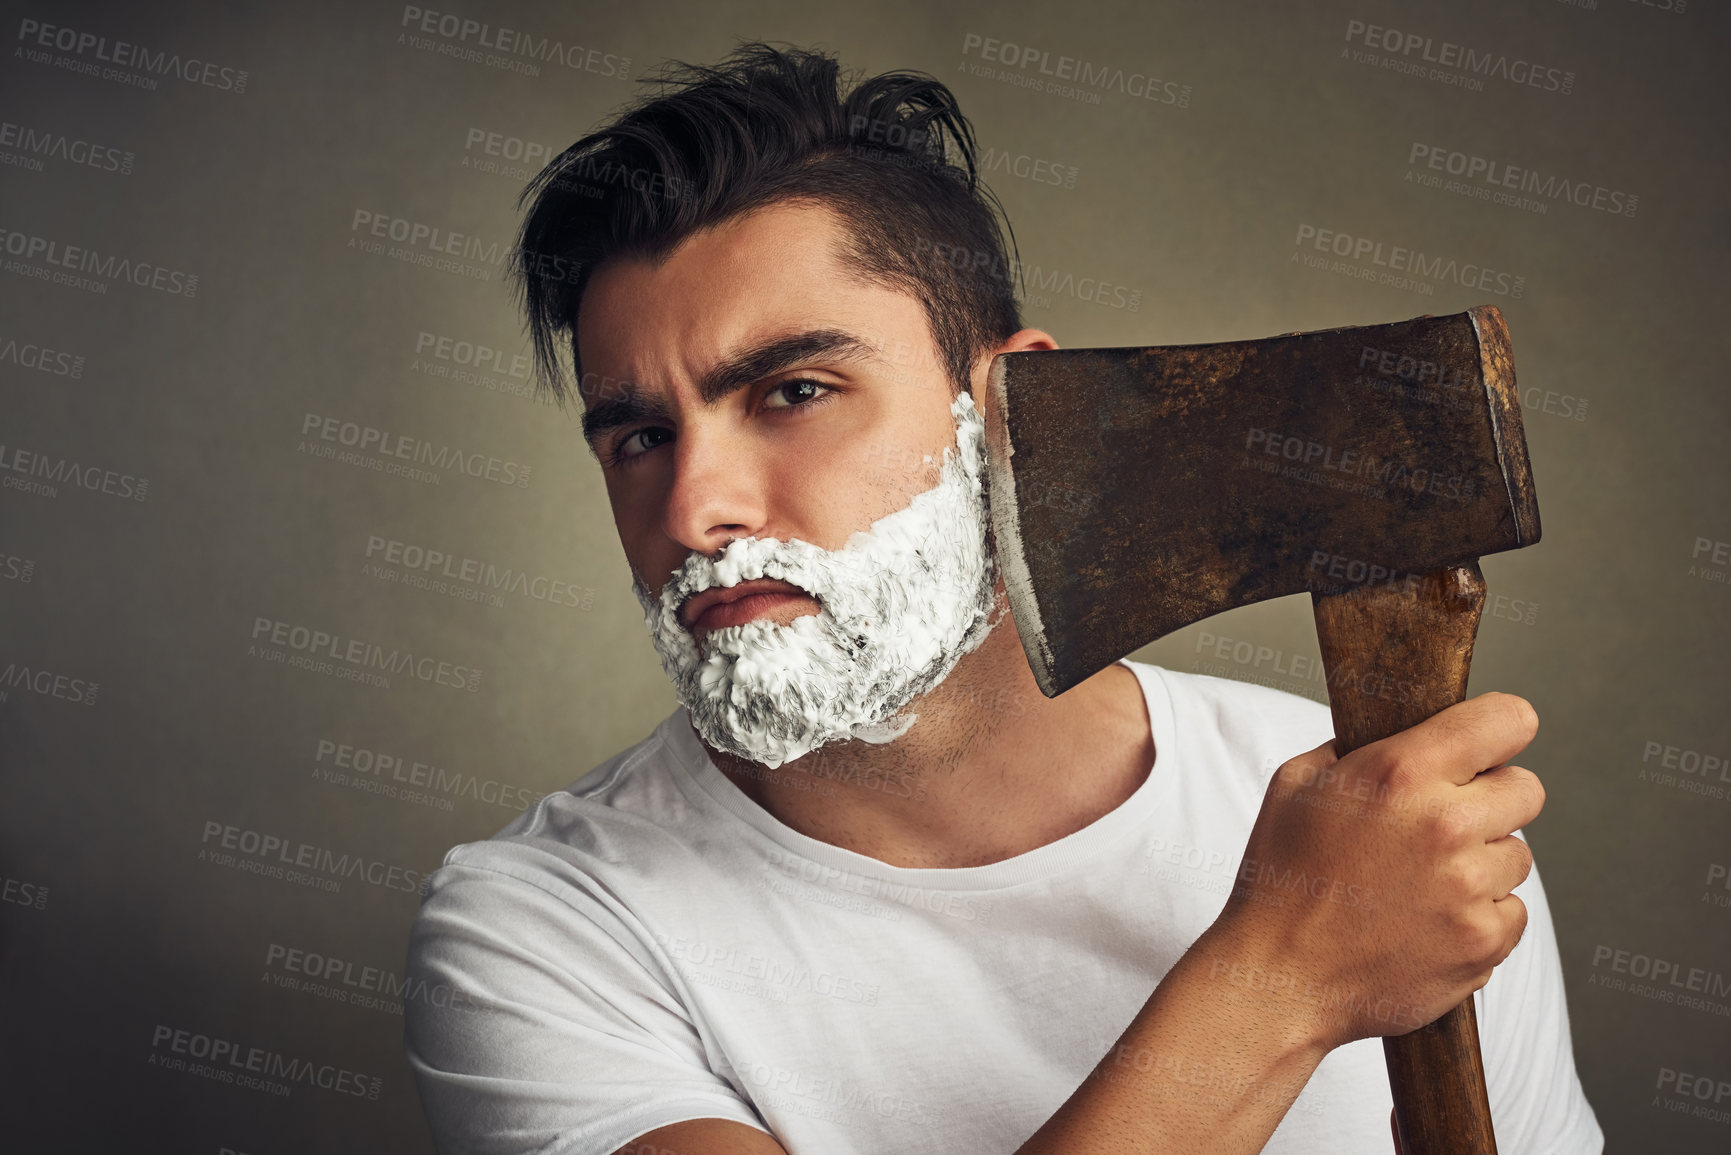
[512,42,1021,403]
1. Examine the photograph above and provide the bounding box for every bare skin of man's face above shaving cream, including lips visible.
[578,204,976,623]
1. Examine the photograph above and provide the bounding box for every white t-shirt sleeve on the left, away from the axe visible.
[405,843,767,1155]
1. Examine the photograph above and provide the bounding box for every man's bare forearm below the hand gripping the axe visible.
[1016,926,1328,1155]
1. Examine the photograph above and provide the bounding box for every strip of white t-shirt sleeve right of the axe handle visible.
[1475,848,1605,1155]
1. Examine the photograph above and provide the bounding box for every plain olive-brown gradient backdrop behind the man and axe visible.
[0,0,1731,1155]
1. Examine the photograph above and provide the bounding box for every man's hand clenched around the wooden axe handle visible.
[1198,693,1544,1048]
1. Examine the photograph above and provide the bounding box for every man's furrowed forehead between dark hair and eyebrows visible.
[576,203,930,400]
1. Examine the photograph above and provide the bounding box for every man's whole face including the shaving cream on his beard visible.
[578,204,1051,765]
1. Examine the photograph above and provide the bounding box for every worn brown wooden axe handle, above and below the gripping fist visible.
[1312,563,1497,1155]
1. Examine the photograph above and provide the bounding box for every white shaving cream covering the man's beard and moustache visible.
[632,393,994,767]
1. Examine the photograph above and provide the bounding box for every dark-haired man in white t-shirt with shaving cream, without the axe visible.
[407,45,1601,1155]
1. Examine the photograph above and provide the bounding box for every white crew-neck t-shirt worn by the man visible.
[407,663,1603,1155]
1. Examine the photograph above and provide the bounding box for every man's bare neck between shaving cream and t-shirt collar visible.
[705,585,1155,868]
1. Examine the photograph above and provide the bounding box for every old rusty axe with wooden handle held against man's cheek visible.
[987,305,1539,1155]
